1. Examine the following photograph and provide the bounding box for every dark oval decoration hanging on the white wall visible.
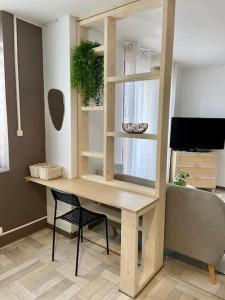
[48,89,65,131]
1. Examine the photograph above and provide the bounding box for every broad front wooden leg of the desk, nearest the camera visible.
[120,210,138,297]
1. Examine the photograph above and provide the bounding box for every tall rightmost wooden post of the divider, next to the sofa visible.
[154,0,176,269]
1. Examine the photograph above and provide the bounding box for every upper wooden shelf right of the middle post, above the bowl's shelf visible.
[107,71,160,83]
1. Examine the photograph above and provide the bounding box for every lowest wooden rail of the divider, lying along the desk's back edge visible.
[81,174,155,198]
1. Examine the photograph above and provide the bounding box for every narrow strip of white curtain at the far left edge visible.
[0,43,9,172]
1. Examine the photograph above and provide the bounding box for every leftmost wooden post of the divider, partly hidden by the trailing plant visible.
[74,23,89,177]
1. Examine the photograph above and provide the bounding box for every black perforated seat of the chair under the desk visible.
[57,207,106,226]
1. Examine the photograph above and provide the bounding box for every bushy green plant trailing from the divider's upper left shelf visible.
[71,40,104,106]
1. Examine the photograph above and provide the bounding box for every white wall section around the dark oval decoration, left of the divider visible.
[43,16,77,232]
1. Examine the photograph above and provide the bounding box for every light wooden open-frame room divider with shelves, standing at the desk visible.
[77,0,175,297]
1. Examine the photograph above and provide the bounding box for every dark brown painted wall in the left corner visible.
[0,12,46,240]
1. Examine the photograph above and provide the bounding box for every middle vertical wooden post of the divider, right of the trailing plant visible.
[104,17,116,180]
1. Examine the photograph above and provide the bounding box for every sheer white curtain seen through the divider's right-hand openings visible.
[123,43,159,180]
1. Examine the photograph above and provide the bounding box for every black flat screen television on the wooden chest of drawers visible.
[170,117,225,151]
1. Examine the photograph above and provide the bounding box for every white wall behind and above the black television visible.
[175,65,225,187]
